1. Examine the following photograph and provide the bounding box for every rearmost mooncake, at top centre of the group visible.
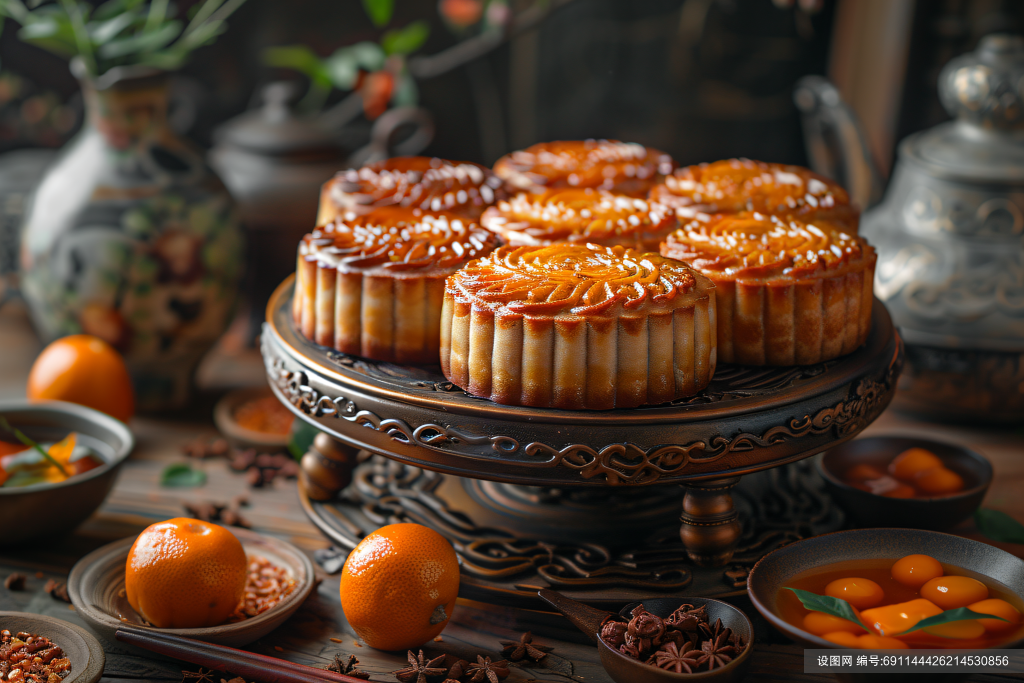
[495,140,676,198]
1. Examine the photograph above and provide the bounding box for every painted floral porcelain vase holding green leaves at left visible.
[22,63,243,411]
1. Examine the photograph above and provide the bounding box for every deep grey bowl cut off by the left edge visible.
[0,400,135,546]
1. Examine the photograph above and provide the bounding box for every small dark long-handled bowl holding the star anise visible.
[538,590,754,683]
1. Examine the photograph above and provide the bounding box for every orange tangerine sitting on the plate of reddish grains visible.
[125,517,248,629]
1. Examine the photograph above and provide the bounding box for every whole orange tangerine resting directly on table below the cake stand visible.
[341,523,459,650]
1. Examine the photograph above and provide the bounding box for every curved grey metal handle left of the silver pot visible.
[793,76,884,211]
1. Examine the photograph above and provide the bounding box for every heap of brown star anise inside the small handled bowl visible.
[600,604,745,674]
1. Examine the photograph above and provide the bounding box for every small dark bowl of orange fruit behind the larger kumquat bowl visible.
[815,436,992,530]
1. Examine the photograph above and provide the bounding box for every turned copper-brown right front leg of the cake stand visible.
[679,477,742,567]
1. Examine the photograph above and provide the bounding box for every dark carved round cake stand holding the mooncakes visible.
[261,279,903,606]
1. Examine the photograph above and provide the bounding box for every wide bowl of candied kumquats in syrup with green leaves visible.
[746,528,1024,650]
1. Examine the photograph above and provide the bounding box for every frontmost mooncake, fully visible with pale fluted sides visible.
[440,244,716,410]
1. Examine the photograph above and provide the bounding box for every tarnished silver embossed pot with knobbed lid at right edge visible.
[861,35,1024,423]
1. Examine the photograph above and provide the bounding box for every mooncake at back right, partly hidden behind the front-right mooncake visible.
[650,159,859,232]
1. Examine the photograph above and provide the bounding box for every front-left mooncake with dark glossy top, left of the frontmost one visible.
[292,207,499,364]
